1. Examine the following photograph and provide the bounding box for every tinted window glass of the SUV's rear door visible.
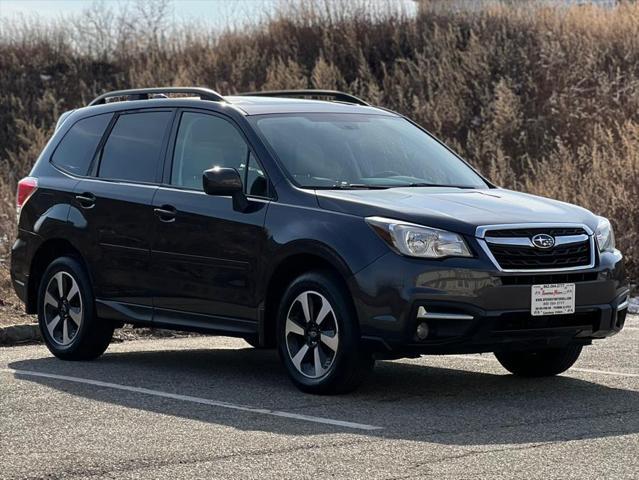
[98,112,172,182]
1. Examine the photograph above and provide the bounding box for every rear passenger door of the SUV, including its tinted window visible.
[75,111,174,321]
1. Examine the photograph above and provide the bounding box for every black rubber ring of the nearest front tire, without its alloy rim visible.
[277,271,362,393]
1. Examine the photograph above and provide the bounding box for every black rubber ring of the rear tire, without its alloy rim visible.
[38,257,95,357]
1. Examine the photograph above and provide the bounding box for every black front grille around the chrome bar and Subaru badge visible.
[486,227,592,270]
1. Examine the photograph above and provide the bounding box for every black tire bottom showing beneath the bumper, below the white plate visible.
[495,345,582,377]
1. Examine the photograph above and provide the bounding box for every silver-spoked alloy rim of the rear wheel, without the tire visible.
[43,272,84,347]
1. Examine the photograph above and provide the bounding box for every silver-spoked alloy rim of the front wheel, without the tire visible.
[284,290,339,379]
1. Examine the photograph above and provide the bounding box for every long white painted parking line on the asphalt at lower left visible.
[0,368,382,430]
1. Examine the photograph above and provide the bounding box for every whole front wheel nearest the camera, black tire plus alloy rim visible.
[277,271,374,394]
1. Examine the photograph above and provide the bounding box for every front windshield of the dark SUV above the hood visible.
[253,113,487,188]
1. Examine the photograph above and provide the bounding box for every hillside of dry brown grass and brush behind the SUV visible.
[0,0,639,312]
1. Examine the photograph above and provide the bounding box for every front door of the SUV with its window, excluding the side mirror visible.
[151,111,269,333]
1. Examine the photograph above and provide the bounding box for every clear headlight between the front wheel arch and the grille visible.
[366,217,473,258]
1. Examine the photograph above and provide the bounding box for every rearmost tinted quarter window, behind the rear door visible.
[51,113,113,175]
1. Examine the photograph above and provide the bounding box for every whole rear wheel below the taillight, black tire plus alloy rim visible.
[38,257,113,360]
